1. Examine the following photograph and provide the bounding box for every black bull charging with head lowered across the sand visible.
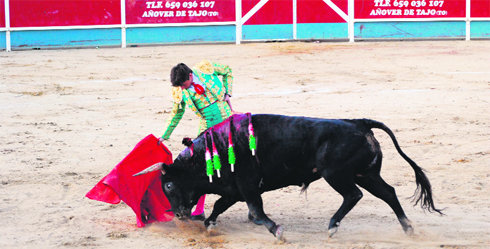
[135,114,441,239]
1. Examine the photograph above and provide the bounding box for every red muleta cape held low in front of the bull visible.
[85,134,174,227]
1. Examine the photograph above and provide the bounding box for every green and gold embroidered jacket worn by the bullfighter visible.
[162,60,233,139]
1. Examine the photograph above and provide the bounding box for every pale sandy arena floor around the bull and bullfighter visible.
[0,41,490,249]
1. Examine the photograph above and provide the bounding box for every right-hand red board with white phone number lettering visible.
[354,0,466,19]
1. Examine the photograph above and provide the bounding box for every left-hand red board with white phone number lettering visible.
[126,0,235,24]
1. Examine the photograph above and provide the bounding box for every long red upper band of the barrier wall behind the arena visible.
[0,0,490,27]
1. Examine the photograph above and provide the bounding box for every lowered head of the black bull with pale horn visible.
[134,160,203,220]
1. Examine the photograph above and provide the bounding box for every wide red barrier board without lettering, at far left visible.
[9,0,121,27]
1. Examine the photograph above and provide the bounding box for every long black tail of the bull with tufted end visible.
[362,119,442,214]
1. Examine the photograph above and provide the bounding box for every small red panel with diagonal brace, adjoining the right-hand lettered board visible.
[297,0,348,23]
